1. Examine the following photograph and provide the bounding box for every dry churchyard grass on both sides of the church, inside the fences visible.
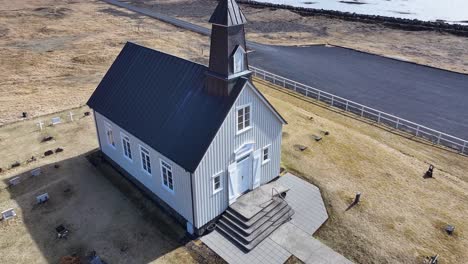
[0,82,468,263]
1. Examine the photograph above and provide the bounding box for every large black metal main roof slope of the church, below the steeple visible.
[88,42,248,172]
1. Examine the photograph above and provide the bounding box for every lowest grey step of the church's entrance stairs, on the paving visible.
[216,206,294,252]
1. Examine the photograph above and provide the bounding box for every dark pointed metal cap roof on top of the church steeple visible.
[209,0,247,26]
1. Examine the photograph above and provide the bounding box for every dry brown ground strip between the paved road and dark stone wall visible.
[127,0,468,73]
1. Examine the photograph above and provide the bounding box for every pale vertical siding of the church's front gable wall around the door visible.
[194,84,282,228]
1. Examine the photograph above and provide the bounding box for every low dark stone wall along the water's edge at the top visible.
[237,0,468,37]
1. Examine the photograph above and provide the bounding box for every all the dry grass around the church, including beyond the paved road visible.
[0,0,468,263]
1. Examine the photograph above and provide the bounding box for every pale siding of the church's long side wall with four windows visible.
[95,112,193,223]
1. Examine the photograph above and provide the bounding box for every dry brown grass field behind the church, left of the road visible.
[0,0,209,125]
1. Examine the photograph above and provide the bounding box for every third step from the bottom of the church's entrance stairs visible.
[219,202,288,236]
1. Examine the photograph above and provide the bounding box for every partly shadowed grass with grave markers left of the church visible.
[0,108,201,264]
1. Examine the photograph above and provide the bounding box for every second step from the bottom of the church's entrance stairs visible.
[218,204,291,244]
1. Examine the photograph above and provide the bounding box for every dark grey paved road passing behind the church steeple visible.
[104,0,468,139]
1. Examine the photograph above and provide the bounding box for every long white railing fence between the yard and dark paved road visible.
[249,66,468,154]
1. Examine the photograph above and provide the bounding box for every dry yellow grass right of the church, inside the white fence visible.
[256,79,468,263]
